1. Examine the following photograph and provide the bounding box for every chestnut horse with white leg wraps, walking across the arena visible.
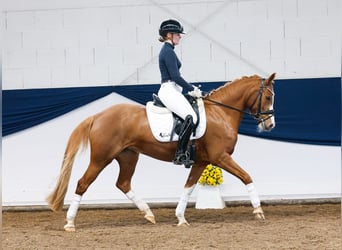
[47,73,275,231]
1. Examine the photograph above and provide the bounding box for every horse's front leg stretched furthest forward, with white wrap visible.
[213,153,265,220]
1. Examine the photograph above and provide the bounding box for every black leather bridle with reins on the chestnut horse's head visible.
[203,79,274,123]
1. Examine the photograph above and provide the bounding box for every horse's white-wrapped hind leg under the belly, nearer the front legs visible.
[116,149,156,224]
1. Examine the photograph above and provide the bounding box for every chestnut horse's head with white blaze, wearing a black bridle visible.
[250,73,276,132]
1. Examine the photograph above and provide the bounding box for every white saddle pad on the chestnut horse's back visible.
[146,99,207,142]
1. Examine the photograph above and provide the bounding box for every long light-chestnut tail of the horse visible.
[46,116,94,212]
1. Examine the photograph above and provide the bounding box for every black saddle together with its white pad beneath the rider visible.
[146,94,206,142]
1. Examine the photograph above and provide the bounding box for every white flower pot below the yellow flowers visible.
[195,185,226,209]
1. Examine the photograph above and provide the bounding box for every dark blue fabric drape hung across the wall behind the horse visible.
[2,77,341,146]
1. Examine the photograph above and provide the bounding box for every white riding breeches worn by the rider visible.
[158,82,197,124]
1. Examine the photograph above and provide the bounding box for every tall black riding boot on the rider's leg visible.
[173,115,195,167]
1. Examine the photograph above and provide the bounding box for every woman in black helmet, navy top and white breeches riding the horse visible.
[158,19,202,166]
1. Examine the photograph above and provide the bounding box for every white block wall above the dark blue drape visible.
[3,0,341,88]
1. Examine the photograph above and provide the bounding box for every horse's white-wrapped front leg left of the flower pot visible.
[176,167,204,226]
